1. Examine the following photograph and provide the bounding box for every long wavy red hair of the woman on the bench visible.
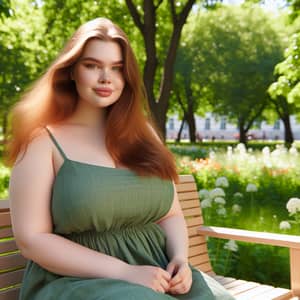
[6,18,178,182]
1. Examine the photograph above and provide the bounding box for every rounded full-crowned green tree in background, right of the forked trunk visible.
[183,6,282,143]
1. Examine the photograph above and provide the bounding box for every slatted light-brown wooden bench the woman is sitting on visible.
[0,175,300,300]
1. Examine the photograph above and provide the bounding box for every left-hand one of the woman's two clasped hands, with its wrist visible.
[124,265,171,293]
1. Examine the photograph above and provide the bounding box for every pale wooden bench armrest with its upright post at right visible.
[198,226,300,296]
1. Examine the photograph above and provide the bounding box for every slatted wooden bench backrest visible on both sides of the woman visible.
[0,175,212,300]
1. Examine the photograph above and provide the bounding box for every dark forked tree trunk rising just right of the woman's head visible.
[126,0,195,137]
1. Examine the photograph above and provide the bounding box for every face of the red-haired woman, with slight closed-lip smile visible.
[72,39,125,108]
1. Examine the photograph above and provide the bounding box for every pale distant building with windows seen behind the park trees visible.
[166,113,300,140]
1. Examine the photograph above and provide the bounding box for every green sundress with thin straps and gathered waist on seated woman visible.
[20,129,234,300]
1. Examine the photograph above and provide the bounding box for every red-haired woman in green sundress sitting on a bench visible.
[5,18,232,300]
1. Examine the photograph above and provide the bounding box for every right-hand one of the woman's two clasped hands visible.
[167,258,193,294]
